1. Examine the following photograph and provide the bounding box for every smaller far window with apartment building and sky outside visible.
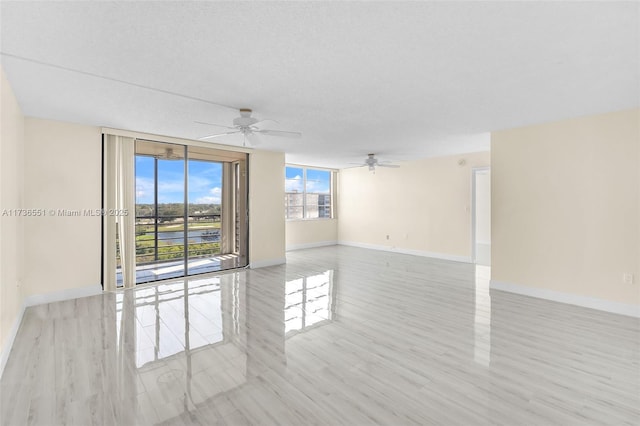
[284,166,333,219]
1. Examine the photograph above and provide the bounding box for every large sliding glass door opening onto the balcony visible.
[129,140,248,284]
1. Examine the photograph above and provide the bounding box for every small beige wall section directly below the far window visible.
[285,219,338,250]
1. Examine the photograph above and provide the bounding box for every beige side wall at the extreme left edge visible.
[0,68,24,356]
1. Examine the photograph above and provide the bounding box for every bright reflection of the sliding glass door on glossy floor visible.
[115,273,247,423]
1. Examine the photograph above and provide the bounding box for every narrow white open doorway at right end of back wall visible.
[472,167,491,266]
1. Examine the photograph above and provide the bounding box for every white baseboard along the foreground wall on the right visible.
[490,280,640,318]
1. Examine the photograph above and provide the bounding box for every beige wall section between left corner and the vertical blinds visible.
[24,118,102,295]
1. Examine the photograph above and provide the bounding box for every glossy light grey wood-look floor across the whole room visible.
[0,246,640,425]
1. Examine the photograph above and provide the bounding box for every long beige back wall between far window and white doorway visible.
[338,152,489,261]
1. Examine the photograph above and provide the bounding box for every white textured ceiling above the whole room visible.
[0,1,640,168]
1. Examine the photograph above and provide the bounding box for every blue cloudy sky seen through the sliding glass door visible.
[136,156,222,204]
